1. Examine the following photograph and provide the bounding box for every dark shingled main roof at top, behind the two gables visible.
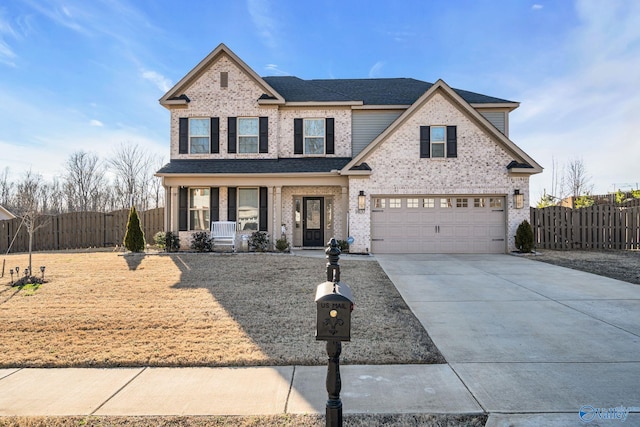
[263,76,513,105]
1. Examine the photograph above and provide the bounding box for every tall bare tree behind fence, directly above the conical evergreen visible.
[109,143,151,210]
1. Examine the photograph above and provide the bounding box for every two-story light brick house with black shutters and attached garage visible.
[157,44,542,253]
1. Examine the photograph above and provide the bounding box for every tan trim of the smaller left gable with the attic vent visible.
[160,43,284,107]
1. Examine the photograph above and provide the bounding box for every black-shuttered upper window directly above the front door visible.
[293,117,335,156]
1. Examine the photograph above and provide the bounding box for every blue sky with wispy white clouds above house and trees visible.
[0,0,640,200]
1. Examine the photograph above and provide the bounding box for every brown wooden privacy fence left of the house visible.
[0,208,164,254]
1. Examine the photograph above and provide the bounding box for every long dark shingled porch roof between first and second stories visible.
[157,157,351,174]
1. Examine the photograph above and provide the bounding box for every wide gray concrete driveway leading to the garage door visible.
[376,254,640,426]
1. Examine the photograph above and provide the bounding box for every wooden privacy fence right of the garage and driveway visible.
[531,203,640,250]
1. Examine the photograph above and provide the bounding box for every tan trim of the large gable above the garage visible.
[341,80,542,175]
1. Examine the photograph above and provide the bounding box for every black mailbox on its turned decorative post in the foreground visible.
[315,238,353,427]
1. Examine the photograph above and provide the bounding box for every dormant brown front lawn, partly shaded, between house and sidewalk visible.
[0,252,444,367]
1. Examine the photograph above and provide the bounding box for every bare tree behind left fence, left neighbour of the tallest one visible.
[64,151,105,212]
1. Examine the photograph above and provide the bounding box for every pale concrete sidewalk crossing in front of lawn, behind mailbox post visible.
[0,365,483,416]
